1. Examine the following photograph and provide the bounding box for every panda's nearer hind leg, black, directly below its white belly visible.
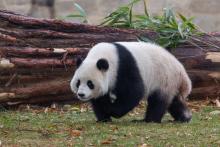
[144,90,168,123]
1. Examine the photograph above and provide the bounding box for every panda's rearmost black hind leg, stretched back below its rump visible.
[168,96,192,122]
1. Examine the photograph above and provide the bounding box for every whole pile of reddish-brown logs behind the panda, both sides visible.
[0,10,220,105]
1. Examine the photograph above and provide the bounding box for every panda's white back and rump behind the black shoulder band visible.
[118,42,190,100]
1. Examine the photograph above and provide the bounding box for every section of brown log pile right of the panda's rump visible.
[174,47,220,99]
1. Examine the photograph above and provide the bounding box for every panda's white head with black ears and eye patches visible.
[70,58,109,101]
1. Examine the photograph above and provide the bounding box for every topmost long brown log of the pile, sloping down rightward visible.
[0,10,155,36]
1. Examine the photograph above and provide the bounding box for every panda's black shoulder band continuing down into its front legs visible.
[92,43,144,121]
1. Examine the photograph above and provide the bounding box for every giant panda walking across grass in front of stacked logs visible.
[70,42,192,123]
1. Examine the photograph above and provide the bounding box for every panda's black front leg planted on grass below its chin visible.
[91,100,112,122]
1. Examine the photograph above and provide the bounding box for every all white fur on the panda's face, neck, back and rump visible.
[70,42,191,102]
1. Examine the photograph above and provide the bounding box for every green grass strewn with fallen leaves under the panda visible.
[0,106,220,147]
